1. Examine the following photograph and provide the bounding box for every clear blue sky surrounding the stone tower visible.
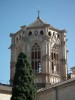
[0,0,75,84]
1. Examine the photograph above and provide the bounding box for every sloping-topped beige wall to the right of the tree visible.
[36,78,75,100]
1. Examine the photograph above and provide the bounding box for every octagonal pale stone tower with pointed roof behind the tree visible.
[10,16,67,88]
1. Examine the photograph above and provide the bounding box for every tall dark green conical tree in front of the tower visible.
[11,52,36,100]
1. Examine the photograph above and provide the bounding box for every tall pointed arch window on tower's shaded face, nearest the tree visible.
[31,43,41,73]
